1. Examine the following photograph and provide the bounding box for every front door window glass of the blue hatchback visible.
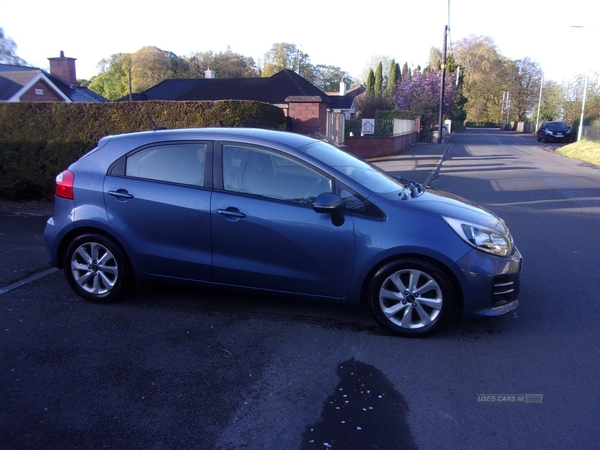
[222,145,332,205]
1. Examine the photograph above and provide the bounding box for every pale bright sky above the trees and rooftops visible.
[0,0,600,82]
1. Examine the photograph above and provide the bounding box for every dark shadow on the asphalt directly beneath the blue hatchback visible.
[107,283,524,340]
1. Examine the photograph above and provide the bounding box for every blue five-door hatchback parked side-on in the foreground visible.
[44,128,521,337]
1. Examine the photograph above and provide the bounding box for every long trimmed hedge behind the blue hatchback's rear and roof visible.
[0,100,285,200]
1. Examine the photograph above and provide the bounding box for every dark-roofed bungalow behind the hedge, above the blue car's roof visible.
[119,69,364,135]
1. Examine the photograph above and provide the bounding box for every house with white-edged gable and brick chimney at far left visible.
[0,51,108,103]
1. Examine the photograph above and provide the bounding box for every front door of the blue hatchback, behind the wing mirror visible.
[211,143,355,297]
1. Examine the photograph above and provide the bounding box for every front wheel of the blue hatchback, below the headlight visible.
[369,259,453,337]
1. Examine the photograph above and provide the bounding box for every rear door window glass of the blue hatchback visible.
[125,144,206,186]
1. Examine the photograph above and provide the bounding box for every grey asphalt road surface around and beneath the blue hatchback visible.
[0,130,600,450]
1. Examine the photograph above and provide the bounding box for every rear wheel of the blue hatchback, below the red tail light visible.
[64,234,134,303]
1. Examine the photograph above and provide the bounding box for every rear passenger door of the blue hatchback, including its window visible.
[104,142,212,281]
